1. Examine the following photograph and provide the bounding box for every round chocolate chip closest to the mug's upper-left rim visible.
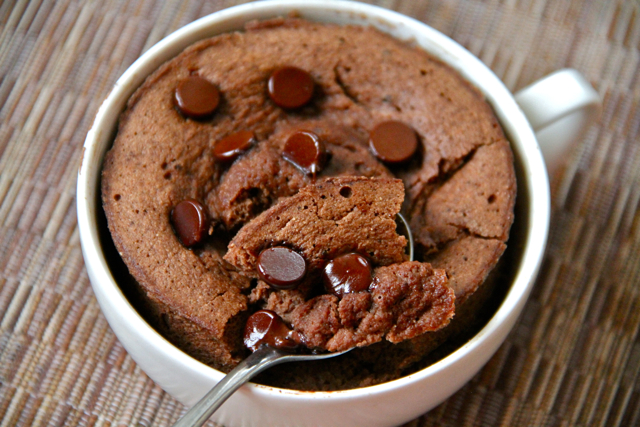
[175,76,220,119]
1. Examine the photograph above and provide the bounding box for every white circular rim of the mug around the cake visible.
[77,0,550,400]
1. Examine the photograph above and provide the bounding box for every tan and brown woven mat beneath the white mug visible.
[0,0,640,426]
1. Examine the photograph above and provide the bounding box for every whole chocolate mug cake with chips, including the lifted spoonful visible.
[102,18,516,390]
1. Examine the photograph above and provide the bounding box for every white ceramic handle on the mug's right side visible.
[514,68,601,177]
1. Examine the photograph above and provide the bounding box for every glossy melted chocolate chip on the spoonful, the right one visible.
[323,252,372,297]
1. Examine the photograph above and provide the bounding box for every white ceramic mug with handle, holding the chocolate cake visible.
[77,0,598,427]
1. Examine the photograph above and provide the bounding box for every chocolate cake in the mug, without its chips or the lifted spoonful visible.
[102,18,516,389]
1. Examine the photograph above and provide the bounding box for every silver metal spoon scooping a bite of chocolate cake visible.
[173,214,413,427]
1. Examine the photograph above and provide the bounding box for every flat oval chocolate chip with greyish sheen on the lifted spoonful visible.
[258,246,307,289]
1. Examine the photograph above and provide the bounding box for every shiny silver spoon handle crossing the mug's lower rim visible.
[173,346,282,427]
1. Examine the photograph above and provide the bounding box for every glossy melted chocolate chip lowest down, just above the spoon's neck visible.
[244,310,298,351]
